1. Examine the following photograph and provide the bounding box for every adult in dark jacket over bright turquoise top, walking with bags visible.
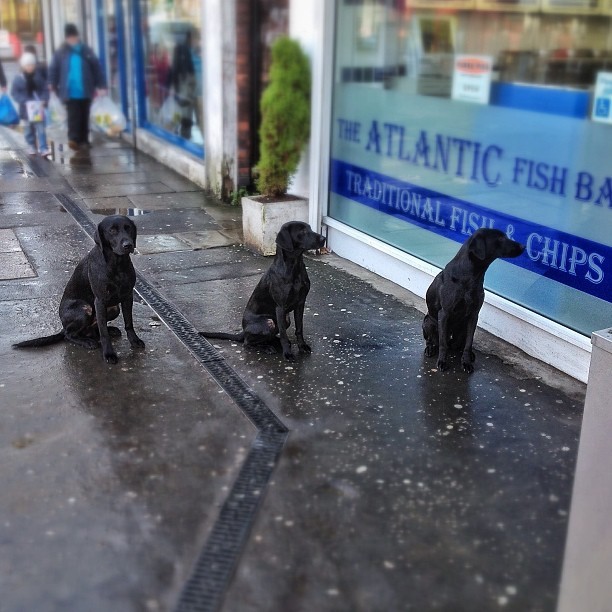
[49,23,106,151]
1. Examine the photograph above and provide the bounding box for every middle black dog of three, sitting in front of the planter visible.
[200,221,325,361]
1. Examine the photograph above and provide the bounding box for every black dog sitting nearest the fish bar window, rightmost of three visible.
[423,229,525,373]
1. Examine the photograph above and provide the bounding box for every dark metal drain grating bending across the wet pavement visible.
[49,194,289,612]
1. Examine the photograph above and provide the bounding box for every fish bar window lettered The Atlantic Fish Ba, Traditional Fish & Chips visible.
[328,0,612,334]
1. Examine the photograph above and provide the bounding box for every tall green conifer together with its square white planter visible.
[242,36,310,255]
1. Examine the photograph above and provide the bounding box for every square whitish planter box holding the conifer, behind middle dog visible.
[242,195,308,255]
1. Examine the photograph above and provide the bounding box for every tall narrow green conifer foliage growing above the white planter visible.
[257,36,310,197]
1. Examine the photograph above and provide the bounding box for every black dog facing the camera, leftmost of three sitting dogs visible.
[13,215,144,363]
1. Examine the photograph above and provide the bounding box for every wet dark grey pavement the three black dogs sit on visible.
[0,125,584,612]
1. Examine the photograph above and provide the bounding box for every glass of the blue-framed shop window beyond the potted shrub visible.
[140,0,204,147]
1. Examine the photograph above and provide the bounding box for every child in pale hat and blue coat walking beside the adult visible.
[11,53,50,157]
